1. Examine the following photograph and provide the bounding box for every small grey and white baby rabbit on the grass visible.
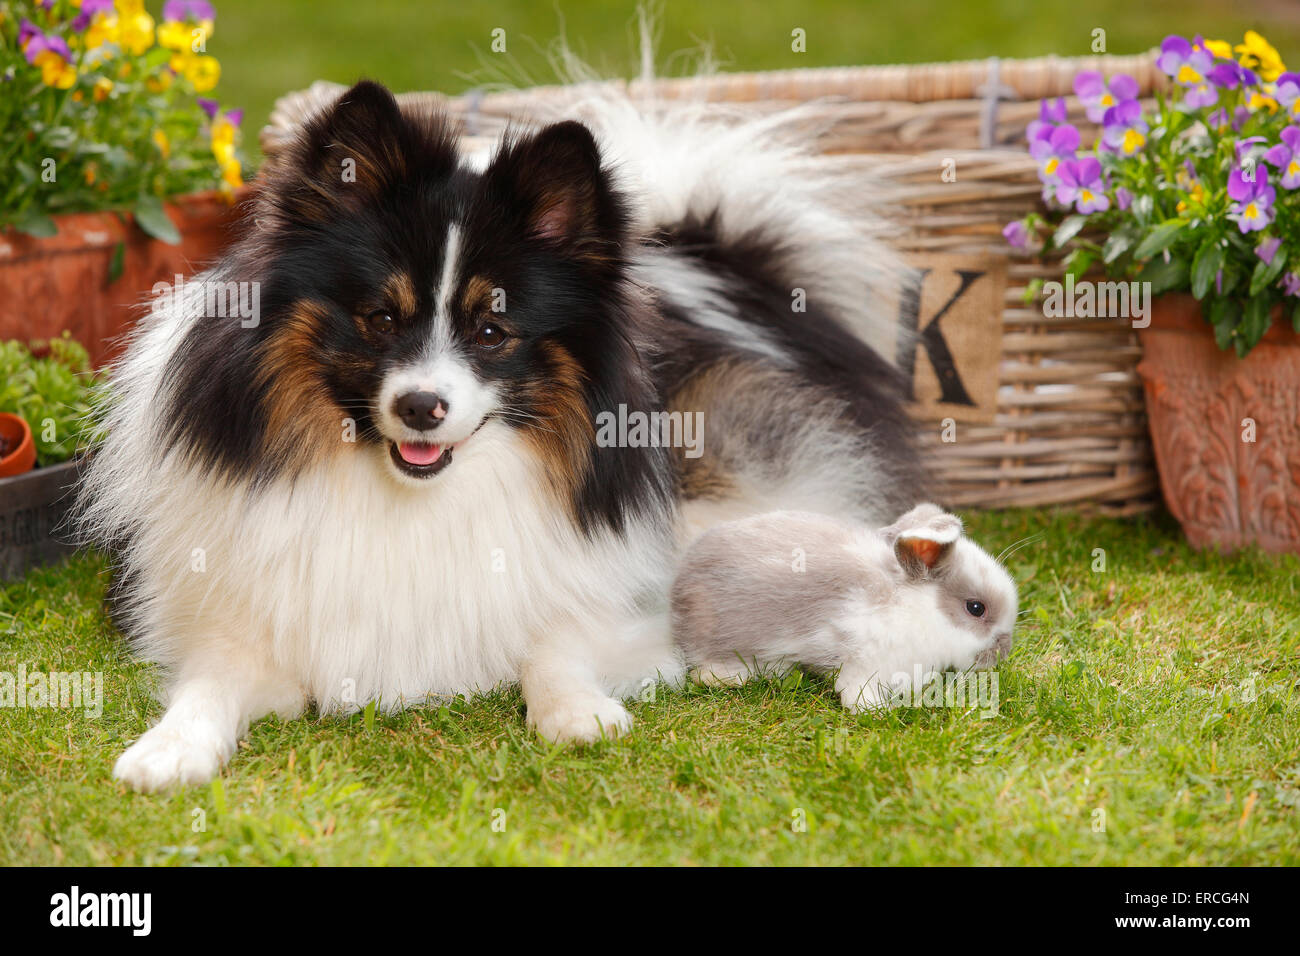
[672,503,1018,711]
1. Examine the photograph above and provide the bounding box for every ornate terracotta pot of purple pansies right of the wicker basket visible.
[1138,294,1300,553]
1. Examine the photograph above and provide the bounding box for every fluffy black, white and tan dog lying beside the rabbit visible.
[79,82,924,792]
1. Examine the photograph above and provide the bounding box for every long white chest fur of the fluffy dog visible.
[124,424,667,710]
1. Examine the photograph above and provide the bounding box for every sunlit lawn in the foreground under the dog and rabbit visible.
[0,511,1300,865]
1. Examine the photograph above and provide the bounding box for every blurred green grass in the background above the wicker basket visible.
[202,0,1300,162]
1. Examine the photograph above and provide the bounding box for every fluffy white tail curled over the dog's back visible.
[527,34,909,362]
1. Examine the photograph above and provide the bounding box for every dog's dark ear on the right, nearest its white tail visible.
[484,120,624,259]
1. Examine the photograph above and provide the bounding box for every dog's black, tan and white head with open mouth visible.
[169,82,651,530]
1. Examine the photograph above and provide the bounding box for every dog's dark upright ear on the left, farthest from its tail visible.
[267,81,411,221]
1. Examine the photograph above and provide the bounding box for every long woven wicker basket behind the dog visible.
[261,53,1164,512]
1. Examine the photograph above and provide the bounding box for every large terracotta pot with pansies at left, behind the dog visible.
[0,191,244,365]
